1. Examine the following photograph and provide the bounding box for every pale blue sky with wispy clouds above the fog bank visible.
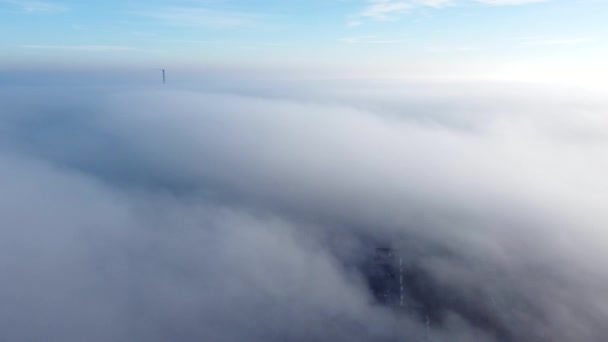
[0,0,608,83]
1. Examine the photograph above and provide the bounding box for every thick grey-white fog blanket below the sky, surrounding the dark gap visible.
[0,76,608,341]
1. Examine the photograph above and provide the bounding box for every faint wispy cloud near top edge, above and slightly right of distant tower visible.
[131,6,261,29]
